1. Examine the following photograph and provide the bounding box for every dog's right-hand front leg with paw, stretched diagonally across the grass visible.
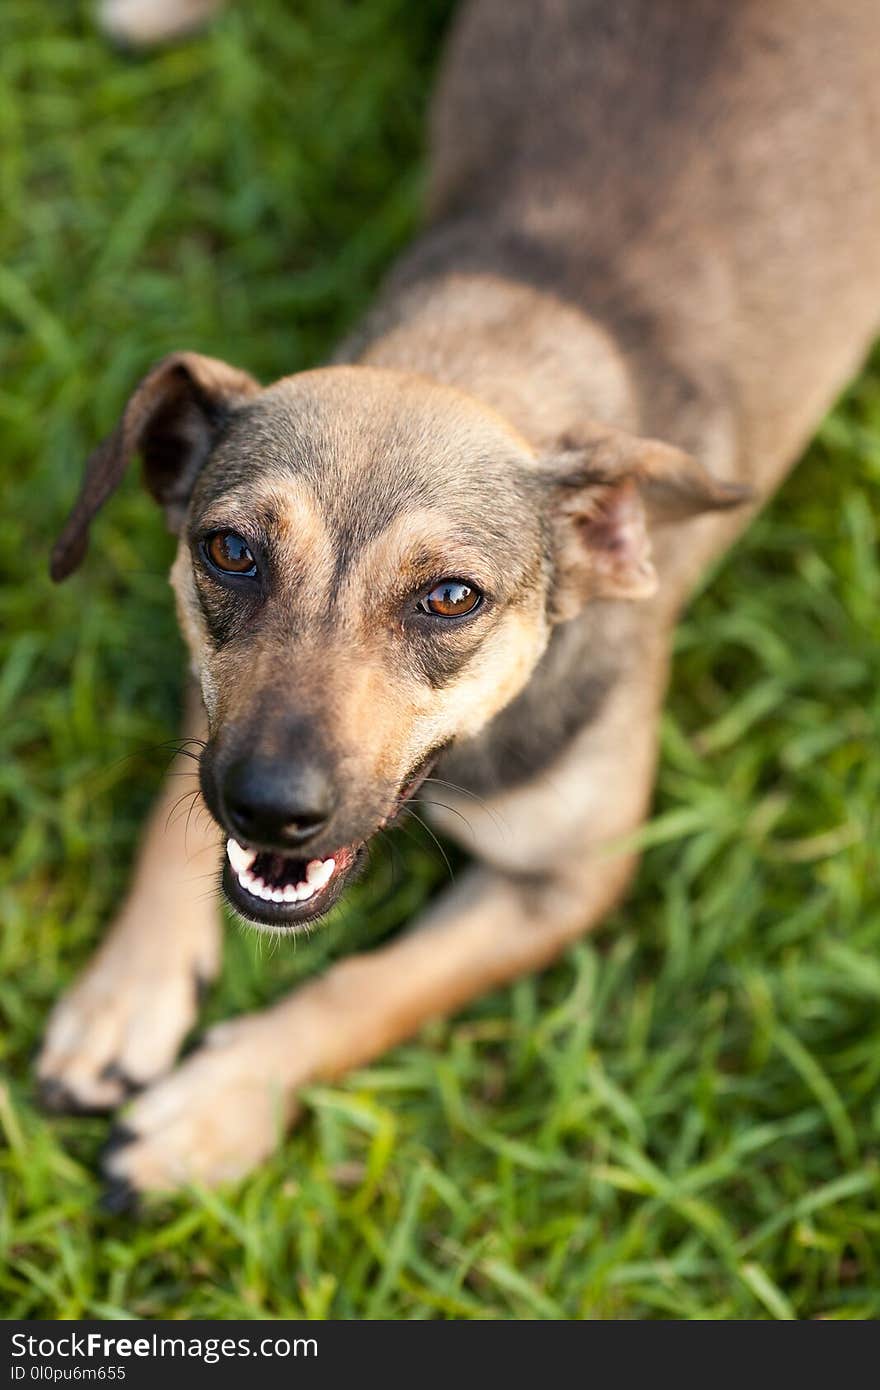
[106,855,633,1204]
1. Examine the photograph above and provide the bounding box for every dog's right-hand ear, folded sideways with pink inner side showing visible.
[549,425,753,621]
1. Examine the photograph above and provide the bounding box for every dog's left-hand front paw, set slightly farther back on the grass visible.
[36,912,220,1112]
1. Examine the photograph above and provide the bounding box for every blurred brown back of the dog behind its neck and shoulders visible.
[416,0,880,487]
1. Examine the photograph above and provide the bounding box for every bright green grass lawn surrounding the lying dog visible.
[0,0,880,1319]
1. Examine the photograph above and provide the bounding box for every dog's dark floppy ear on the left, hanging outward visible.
[50,352,260,580]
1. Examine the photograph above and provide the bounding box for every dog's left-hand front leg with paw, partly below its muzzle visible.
[38,689,220,1111]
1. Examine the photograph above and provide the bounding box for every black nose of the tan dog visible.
[222,758,335,849]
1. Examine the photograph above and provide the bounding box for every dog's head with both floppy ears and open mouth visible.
[53,353,742,927]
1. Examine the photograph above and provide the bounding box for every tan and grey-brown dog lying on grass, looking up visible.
[38,0,880,1201]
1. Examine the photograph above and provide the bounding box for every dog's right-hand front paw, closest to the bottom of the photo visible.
[103,1015,296,1211]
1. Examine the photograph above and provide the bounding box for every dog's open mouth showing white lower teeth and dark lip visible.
[222,838,357,929]
